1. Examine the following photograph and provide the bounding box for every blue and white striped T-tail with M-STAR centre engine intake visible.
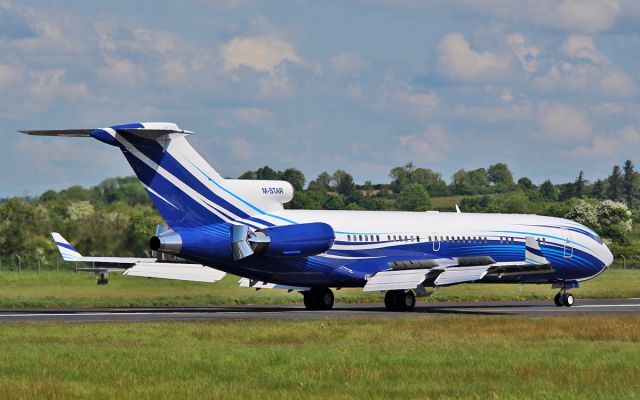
[21,122,293,228]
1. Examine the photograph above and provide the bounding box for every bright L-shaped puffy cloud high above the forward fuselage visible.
[437,33,512,82]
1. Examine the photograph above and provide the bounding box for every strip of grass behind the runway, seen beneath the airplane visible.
[0,269,640,307]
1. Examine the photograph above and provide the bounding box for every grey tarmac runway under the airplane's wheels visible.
[0,298,640,323]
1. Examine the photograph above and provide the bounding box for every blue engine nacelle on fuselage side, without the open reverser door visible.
[248,222,336,257]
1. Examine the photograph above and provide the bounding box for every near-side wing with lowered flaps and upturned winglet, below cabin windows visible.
[363,237,553,292]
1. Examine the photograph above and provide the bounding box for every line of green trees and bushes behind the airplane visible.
[0,160,640,256]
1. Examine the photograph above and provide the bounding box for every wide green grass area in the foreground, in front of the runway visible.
[0,316,640,399]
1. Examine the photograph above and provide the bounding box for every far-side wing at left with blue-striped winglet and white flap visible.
[51,232,226,283]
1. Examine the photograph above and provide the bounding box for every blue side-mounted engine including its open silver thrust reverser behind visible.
[232,222,336,260]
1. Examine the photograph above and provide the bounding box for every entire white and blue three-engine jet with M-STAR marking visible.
[22,122,613,311]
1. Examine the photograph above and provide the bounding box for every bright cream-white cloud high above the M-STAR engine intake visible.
[220,37,303,74]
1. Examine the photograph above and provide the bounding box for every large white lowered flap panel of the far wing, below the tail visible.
[123,263,226,283]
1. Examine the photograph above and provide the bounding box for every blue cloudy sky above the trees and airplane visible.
[0,0,640,197]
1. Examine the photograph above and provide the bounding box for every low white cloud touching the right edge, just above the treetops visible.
[569,126,640,160]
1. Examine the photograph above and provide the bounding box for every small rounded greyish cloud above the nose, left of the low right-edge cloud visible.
[538,103,592,143]
